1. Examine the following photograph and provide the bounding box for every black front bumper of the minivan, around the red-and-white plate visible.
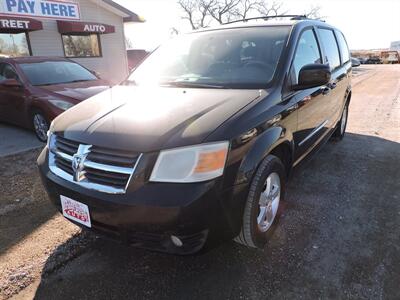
[38,149,246,254]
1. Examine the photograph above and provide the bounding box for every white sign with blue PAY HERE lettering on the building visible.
[0,0,80,20]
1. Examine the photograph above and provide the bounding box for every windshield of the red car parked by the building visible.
[20,61,97,85]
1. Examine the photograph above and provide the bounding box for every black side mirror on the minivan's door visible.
[293,64,331,90]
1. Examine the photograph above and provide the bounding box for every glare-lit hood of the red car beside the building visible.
[40,80,110,101]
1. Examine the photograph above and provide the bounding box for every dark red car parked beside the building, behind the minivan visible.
[0,57,110,142]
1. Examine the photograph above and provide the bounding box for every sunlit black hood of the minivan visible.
[53,86,265,152]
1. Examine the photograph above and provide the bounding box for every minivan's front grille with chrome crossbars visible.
[49,136,141,193]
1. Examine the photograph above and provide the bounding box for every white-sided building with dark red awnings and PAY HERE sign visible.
[0,0,142,83]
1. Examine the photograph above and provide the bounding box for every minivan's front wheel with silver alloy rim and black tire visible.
[235,155,286,249]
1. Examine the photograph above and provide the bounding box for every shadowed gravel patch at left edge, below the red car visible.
[0,150,57,255]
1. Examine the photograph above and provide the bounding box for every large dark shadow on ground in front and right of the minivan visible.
[36,134,400,299]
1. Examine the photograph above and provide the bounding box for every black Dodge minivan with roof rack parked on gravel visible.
[38,16,351,254]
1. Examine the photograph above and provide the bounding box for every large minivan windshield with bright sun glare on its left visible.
[126,26,290,88]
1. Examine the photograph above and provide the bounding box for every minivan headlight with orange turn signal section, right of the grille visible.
[150,142,229,182]
